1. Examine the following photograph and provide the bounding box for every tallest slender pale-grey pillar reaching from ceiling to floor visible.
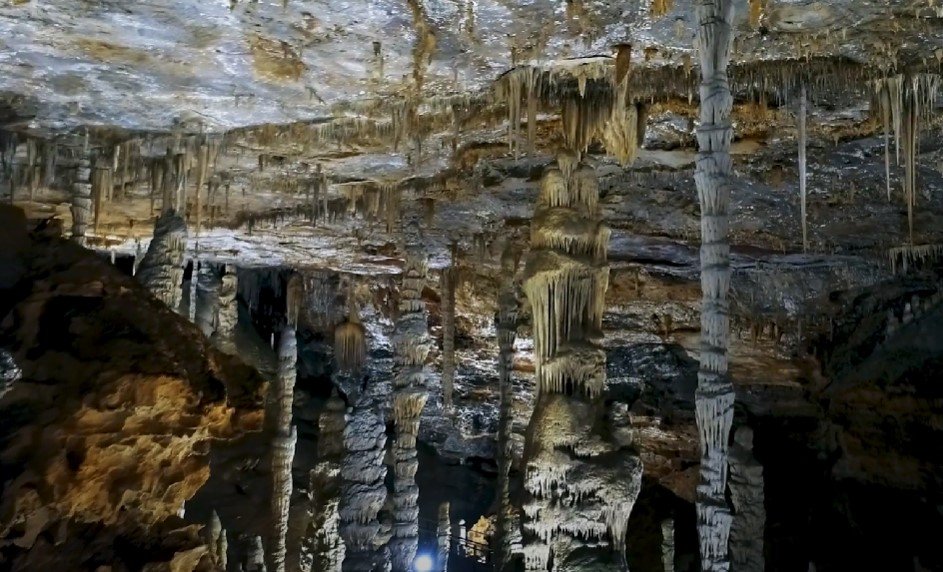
[694,0,734,572]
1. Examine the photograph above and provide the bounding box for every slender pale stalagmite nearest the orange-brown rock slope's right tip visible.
[269,326,298,572]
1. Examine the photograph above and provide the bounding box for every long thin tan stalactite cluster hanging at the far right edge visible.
[873,74,940,244]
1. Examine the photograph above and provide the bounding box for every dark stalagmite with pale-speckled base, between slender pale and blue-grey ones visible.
[300,390,345,572]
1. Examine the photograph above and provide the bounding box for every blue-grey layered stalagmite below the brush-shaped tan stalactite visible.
[339,379,390,572]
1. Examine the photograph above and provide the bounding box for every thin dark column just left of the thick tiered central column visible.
[494,245,520,571]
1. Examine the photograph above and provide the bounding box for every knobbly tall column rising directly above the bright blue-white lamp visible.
[390,221,432,572]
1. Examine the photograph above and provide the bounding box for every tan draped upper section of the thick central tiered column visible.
[524,161,609,397]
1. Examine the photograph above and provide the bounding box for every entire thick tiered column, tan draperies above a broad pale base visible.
[523,161,642,570]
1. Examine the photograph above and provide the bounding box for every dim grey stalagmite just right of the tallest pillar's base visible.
[730,426,766,572]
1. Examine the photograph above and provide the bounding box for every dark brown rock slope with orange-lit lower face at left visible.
[0,209,263,570]
